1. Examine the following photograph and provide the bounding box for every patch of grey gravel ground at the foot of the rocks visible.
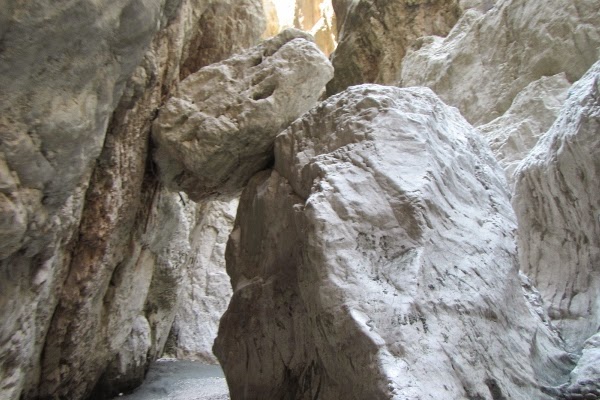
[115,359,229,400]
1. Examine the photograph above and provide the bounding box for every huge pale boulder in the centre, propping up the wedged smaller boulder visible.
[214,85,568,399]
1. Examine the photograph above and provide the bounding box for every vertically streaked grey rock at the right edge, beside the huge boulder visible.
[513,62,600,351]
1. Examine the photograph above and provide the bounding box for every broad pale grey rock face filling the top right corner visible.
[398,0,600,125]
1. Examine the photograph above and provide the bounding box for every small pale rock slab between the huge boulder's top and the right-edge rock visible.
[478,73,571,181]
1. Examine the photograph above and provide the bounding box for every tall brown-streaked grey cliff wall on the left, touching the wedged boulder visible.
[0,0,264,400]
